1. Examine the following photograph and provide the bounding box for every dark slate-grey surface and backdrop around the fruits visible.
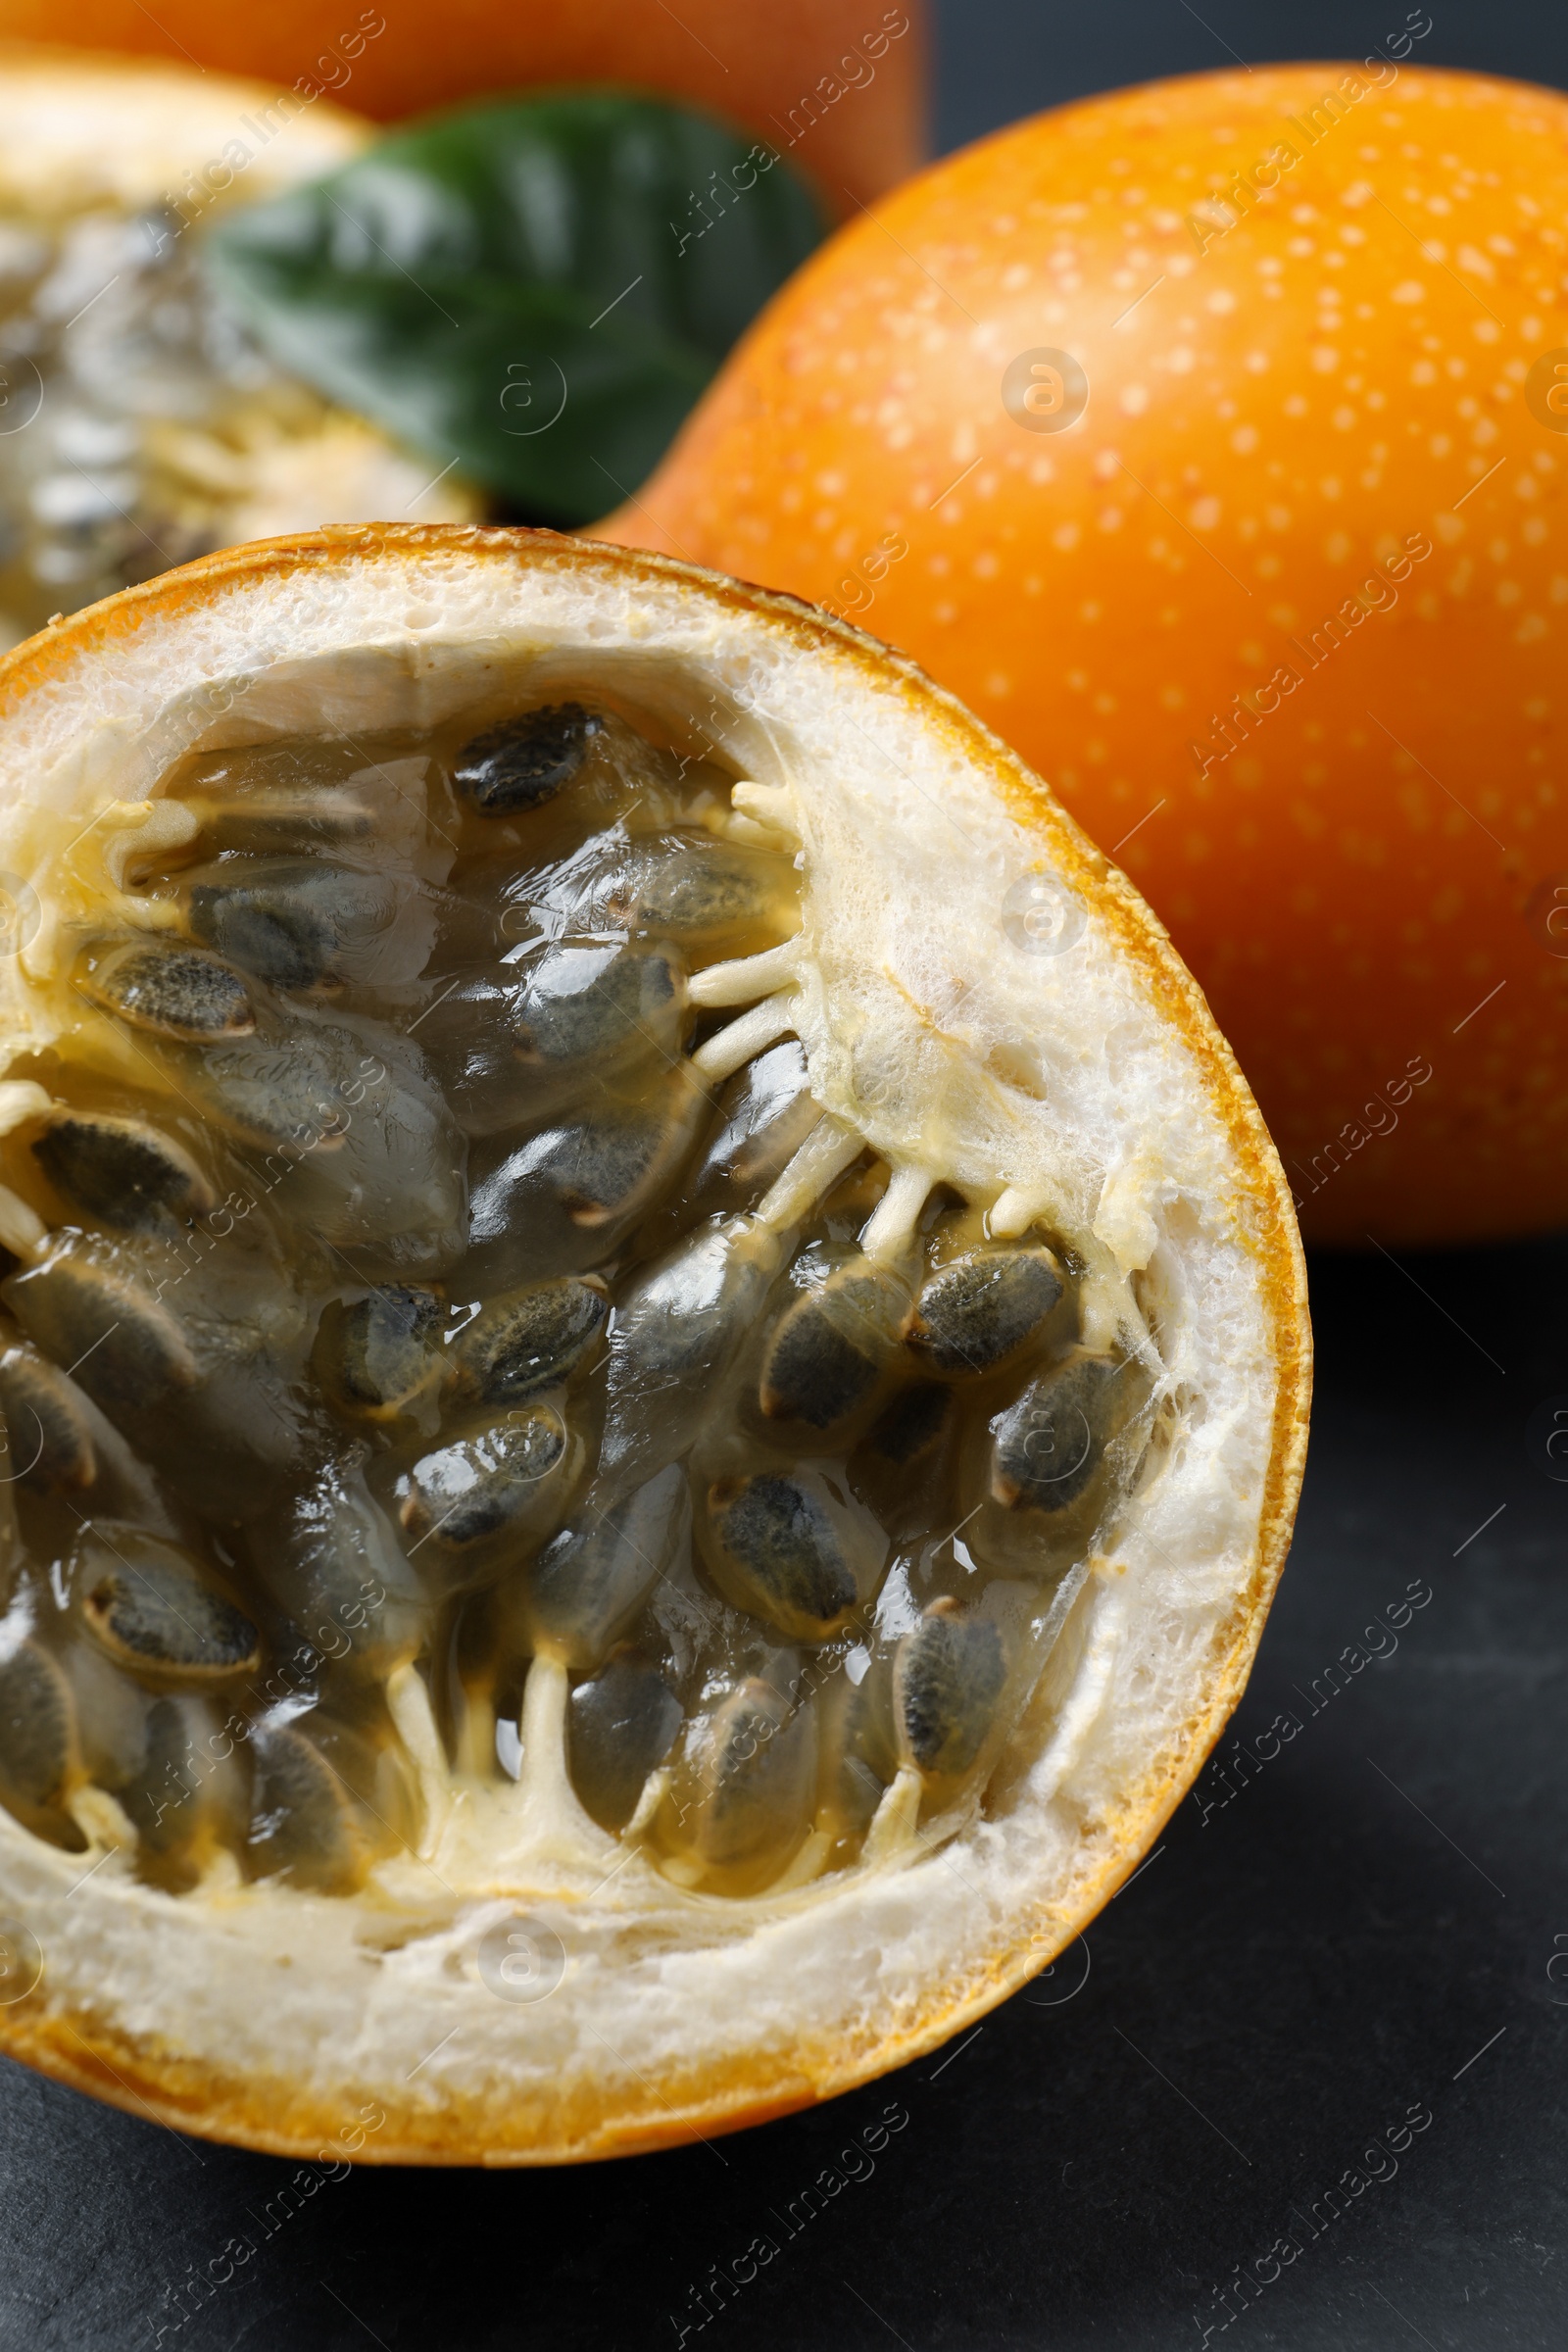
[0,0,1568,2352]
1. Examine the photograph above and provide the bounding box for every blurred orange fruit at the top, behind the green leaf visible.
[0,0,926,217]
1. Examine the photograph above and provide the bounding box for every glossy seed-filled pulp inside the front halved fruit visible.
[0,689,1148,1895]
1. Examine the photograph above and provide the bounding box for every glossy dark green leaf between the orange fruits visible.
[207,89,827,527]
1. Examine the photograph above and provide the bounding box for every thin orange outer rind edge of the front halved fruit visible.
[0,527,1309,2162]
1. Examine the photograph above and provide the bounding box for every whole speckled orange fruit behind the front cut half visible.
[604,59,1568,1245]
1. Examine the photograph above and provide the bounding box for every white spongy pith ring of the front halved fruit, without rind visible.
[0,548,1277,2157]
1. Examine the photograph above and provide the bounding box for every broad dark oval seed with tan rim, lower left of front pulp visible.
[71,1519,261,1684]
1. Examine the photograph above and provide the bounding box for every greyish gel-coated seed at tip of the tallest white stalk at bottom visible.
[522,1463,686,1668]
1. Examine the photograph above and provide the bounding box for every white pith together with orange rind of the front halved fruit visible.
[0,531,1307,2164]
